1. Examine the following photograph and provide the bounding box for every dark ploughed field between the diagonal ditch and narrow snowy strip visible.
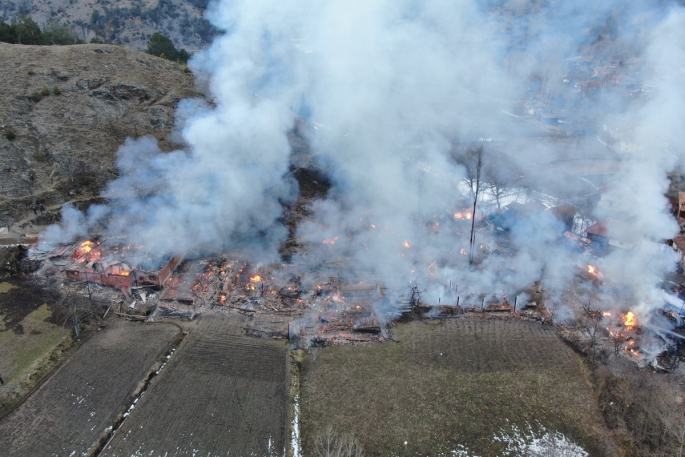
[101,316,287,457]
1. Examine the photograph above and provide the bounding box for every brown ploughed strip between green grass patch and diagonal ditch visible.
[0,320,179,457]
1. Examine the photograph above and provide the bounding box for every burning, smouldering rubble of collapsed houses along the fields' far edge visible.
[25,148,684,363]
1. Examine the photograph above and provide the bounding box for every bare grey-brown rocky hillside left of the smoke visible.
[0,43,202,233]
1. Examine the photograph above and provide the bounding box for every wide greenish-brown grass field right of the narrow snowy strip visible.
[301,318,606,456]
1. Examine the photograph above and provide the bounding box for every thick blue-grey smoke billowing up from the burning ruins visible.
[41,0,685,334]
